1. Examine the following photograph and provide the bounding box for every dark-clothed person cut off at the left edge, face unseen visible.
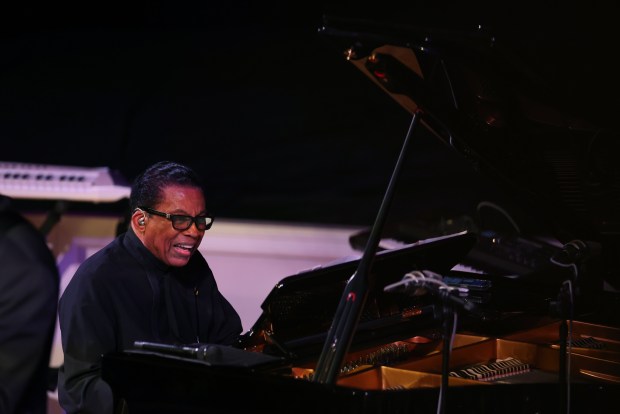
[0,195,60,414]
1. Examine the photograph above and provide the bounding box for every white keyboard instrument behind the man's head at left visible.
[0,162,131,203]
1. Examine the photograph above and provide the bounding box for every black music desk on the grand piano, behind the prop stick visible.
[241,232,476,361]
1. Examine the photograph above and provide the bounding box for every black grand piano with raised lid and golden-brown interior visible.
[102,6,620,414]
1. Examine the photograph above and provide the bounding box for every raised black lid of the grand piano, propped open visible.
[320,8,620,287]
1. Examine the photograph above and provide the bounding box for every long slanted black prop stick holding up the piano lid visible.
[313,110,421,385]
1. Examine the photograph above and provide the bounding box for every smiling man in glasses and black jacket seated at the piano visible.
[58,161,242,414]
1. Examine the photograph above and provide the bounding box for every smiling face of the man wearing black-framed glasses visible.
[140,185,207,267]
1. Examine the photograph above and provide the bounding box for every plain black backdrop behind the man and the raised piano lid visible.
[0,0,616,238]
